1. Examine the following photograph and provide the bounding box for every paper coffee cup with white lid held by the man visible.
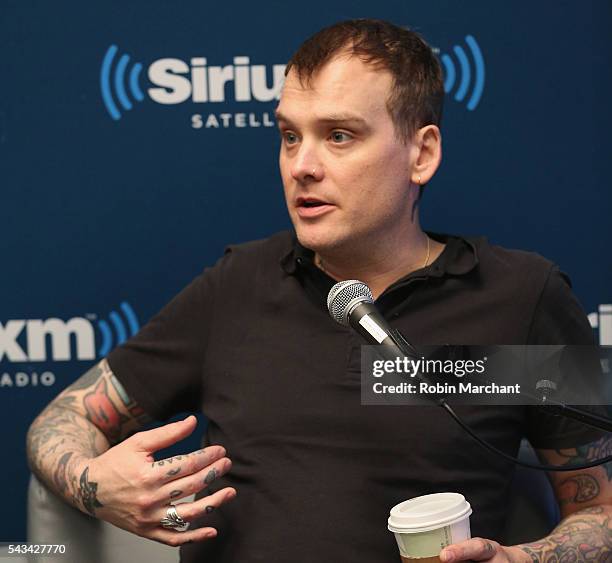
[387,493,472,561]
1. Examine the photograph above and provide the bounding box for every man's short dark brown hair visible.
[285,19,444,142]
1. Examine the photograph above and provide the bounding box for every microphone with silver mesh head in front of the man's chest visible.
[327,280,418,359]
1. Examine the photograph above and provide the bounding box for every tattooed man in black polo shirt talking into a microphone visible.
[28,20,612,563]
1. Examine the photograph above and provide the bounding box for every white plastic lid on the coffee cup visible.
[388,493,472,534]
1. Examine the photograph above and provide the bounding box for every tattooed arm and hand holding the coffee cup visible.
[440,437,612,563]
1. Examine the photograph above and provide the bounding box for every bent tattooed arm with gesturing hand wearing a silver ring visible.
[27,360,236,546]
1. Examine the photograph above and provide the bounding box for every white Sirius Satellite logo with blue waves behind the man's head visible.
[100,35,485,123]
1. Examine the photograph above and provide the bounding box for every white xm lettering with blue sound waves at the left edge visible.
[0,301,139,362]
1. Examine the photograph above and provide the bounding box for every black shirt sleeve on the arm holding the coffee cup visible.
[526,265,602,449]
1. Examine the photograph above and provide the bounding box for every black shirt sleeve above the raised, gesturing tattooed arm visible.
[107,259,223,420]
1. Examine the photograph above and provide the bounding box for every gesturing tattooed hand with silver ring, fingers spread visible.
[75,416,236,546]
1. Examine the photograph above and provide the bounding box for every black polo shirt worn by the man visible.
[108,232,593,563]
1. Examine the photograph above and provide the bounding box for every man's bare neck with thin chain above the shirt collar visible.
[315,229,444,299]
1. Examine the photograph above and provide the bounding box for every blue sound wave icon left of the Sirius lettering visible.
[100,45,144,121]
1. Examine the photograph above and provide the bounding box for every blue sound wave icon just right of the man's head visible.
[440,35,485,111]
